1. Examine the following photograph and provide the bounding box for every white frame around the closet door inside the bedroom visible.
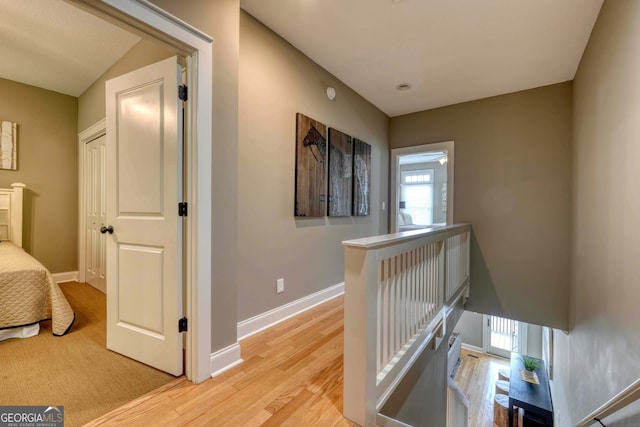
[78,119,107,290]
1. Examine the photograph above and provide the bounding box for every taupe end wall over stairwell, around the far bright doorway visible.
[390,82,572,329]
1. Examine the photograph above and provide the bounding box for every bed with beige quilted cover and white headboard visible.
[0,184,75,340]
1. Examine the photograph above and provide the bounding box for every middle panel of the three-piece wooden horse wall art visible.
[329,128,353,216]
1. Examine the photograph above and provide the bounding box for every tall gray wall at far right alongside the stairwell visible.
[552,0,640,425]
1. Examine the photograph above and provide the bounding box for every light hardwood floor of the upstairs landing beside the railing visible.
[86,297,354,427]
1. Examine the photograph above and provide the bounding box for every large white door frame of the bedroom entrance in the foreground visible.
[70,0,213,383]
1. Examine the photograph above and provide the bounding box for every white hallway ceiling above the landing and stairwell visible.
[240,0,603,117]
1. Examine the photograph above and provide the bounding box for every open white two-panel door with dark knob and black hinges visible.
[105,57,183,375]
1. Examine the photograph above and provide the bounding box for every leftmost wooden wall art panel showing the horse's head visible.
[294,113,327,217]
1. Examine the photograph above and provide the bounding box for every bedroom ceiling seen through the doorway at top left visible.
[0,0,140,96]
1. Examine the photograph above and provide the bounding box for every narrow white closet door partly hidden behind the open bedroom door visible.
[84,135,107,293]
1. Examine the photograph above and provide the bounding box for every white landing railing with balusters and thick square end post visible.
[343,224,470,426]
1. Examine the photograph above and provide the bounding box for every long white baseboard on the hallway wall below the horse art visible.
[238,282,344,341]
